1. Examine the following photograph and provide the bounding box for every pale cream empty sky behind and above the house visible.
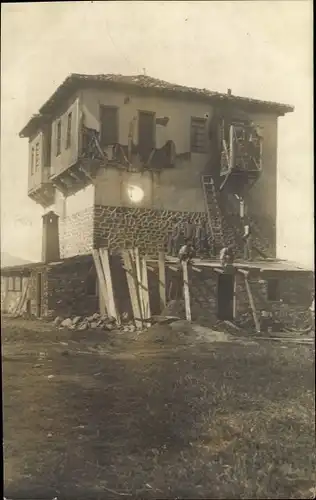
[1,0,314,265]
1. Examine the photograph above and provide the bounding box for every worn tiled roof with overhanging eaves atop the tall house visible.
[20,73,294,137]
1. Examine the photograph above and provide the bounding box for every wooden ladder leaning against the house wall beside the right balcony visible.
[202,175,225,248]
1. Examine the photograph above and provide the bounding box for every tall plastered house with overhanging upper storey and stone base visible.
[1,74,314,328]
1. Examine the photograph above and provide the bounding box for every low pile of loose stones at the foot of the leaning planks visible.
[53,313,136,332]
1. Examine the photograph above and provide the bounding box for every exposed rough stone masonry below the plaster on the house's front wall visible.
[94,205,206,257]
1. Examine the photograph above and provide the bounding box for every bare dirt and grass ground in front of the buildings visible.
[2,318,316,500]
